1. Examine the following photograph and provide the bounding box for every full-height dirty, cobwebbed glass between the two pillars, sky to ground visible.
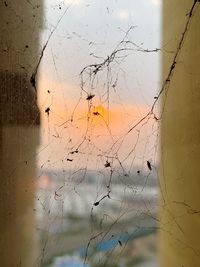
[36,0,161,267]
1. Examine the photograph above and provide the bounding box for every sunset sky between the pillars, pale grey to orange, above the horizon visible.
[39,0,161,171]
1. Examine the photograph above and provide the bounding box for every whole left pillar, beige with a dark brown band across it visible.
[0,0,42,267]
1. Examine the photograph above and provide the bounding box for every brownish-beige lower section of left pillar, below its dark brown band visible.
[0,126,39,267]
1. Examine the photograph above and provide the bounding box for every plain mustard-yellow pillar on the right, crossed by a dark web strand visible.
[159,0,200,267]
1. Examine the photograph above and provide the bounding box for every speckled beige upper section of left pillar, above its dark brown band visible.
[0,0,43,75]
